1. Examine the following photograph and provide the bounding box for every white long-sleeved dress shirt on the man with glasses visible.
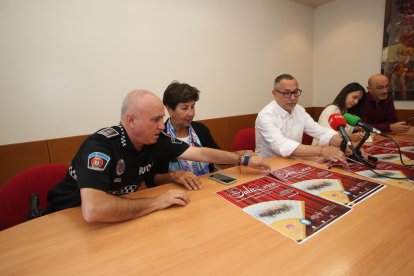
[255,100,337,157]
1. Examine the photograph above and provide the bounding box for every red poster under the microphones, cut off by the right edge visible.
[326,161,414,191]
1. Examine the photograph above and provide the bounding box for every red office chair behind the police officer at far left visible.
[0,164,68,230]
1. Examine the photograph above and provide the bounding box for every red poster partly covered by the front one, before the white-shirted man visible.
[271,163,385,206]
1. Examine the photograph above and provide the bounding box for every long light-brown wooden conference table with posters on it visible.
[0,137,414,275]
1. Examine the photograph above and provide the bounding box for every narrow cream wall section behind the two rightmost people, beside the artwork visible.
[313,0,414,109]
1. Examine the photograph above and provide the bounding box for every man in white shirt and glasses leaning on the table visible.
[256,74,346,163]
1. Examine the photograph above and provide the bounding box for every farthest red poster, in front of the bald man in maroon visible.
[362,146,414,165]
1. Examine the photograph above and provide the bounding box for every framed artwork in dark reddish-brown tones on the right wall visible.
[381,0,414,101]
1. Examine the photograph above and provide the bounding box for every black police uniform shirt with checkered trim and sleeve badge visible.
[46,124,189,213]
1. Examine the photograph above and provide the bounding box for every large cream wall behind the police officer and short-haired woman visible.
[0,0,314,144]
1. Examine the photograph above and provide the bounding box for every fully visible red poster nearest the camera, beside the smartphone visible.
[216,176,351,243]
